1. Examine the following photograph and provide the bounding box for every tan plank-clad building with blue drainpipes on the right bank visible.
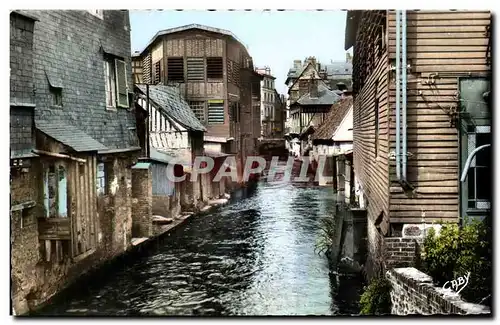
[345,10,491,274]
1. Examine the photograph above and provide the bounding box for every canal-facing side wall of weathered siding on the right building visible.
[353,53,389,233]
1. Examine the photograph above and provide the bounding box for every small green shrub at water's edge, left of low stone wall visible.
[359,276,391,315]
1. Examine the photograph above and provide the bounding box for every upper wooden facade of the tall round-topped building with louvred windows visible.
[137,25,260,149]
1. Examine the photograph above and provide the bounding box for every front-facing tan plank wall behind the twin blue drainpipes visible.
[388,11,490,223]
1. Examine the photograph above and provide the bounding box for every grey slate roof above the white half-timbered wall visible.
[136,84,207,131]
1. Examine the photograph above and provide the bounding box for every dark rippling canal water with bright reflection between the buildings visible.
[37,182,362,316]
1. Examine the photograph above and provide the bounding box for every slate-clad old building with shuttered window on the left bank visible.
[10,10,140,314]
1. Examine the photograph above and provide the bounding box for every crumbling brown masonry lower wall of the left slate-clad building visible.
[11,157,132,314]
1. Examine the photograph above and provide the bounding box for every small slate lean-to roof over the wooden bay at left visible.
[35,120,108,152]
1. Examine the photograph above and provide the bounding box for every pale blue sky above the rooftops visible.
[130,10,352,94]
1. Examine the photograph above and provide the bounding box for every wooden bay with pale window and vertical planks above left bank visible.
[37,134,99,262]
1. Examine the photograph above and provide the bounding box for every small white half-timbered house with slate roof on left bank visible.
[133,84,206,233]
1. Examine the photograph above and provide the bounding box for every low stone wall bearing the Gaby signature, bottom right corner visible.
[386,267,490,315]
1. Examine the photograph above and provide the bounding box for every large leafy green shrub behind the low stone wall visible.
[422,221,492,304]
